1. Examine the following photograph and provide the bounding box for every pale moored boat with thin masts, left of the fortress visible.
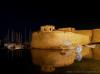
[4,28,24,50]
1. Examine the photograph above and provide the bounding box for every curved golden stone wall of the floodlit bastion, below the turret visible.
[32,31,90,49]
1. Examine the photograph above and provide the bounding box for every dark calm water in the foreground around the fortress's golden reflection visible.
[0,49,100,74]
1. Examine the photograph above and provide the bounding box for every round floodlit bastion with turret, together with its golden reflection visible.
[31,25,90,72]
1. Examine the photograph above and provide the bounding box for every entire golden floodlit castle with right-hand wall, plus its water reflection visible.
[31,25,100,71]
